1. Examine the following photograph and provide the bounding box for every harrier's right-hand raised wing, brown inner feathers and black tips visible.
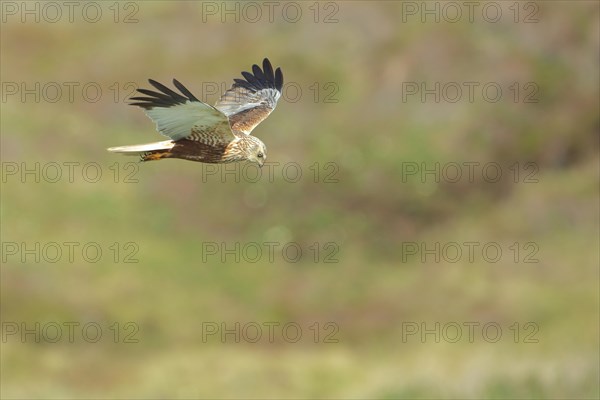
[215,58,283,134]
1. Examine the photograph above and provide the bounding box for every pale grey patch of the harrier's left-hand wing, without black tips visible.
[144,100,234,141]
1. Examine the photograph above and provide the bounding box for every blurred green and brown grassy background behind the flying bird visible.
[0,1,600,398]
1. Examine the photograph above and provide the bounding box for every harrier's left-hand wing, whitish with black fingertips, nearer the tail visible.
[130,79,235,144]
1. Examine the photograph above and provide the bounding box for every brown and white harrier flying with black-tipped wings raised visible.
[108,58,283,167]
